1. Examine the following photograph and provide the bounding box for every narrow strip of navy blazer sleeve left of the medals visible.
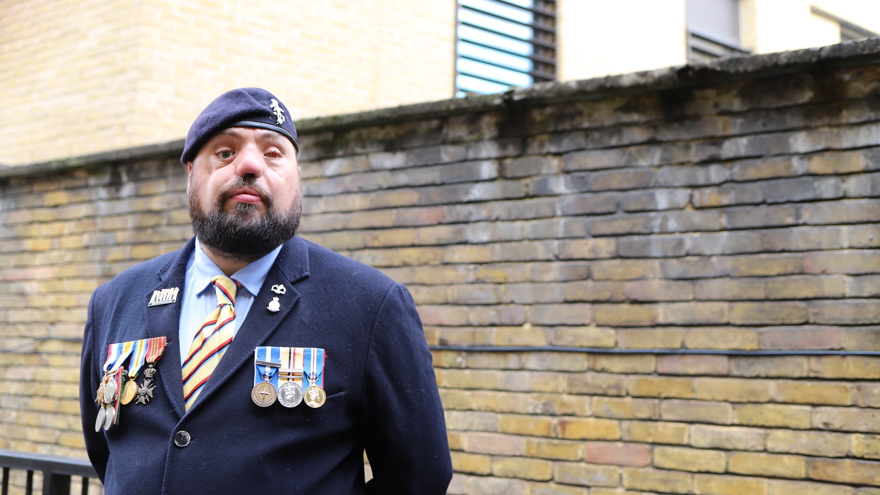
[79,289,110,482]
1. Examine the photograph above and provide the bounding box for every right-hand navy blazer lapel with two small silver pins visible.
[186,237,309,412]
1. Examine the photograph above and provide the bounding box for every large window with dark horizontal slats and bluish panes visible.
[455,0,556,96]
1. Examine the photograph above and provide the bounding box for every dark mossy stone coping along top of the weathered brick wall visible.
[0,38,880,180]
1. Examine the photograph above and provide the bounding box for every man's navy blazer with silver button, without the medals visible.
[80,237,452,495]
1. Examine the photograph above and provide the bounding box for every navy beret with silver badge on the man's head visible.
[180,88,299,163]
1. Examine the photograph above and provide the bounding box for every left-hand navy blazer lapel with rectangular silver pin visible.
[146,238,195,416]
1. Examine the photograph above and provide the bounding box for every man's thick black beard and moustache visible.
[189,179,302,263]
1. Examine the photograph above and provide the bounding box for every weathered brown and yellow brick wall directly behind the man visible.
[0,42,880,495]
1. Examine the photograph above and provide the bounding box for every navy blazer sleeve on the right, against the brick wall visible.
[361,284,452,495]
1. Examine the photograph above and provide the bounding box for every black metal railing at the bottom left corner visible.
[0,449,98,495]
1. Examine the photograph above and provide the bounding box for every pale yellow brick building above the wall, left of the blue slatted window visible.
[0,0,455,165]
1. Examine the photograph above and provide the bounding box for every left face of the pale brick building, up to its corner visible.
[0,0,144,164]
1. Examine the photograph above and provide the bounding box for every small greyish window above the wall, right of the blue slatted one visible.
[686,0,748,62]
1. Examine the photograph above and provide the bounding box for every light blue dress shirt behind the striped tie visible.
[178,239,281,363]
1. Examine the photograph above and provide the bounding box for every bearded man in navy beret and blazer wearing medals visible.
[80,88,452,495]
